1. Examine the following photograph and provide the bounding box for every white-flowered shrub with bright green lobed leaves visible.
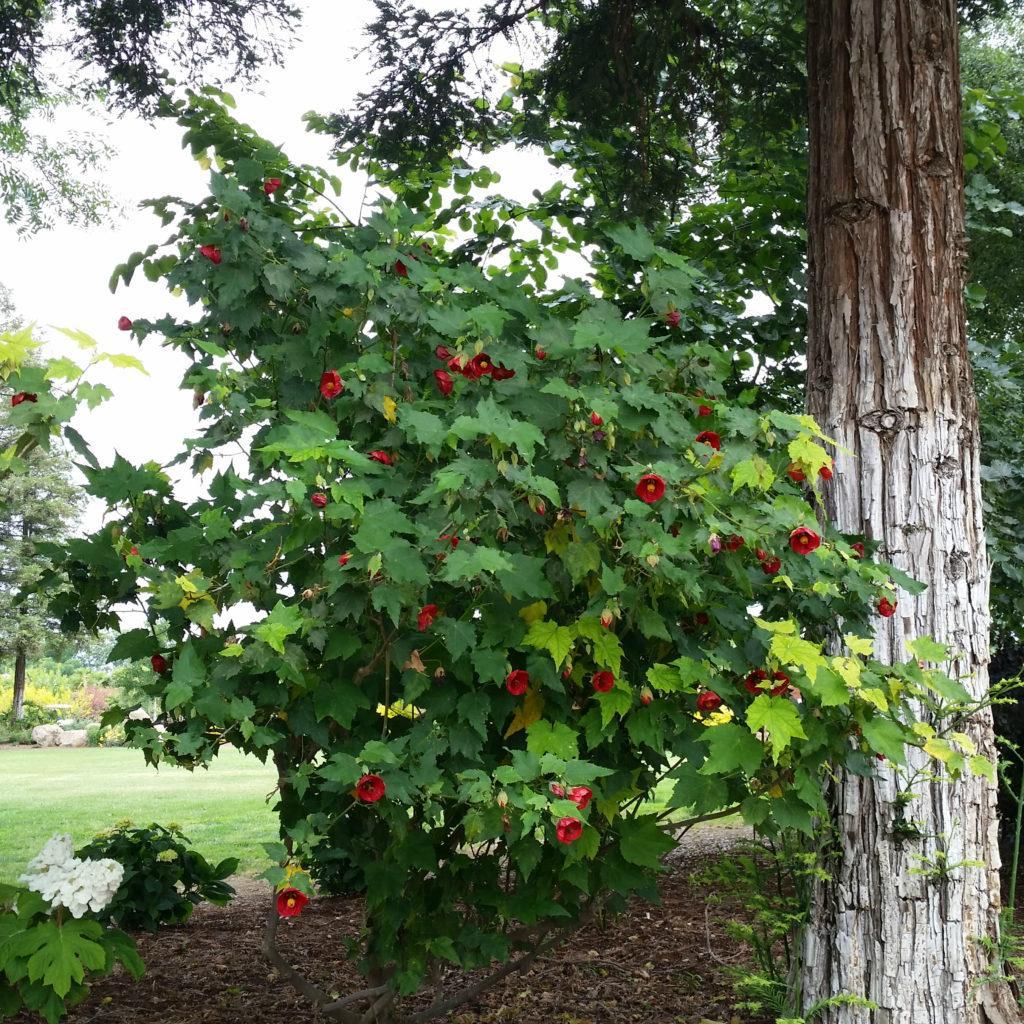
[0,836,143,1024]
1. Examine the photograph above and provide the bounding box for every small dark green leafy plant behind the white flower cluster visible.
[78,821,239,932]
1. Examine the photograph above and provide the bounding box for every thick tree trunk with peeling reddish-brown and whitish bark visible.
[803,0,1018,1024]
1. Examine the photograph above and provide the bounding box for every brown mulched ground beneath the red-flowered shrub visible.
[36,827,765,1024]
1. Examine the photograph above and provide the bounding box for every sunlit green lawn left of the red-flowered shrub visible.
[0,748,278,882]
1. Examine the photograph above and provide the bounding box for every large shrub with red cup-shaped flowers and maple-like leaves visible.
[13,94,983,1021]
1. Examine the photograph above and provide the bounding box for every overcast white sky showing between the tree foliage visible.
[0,0,552,528]
